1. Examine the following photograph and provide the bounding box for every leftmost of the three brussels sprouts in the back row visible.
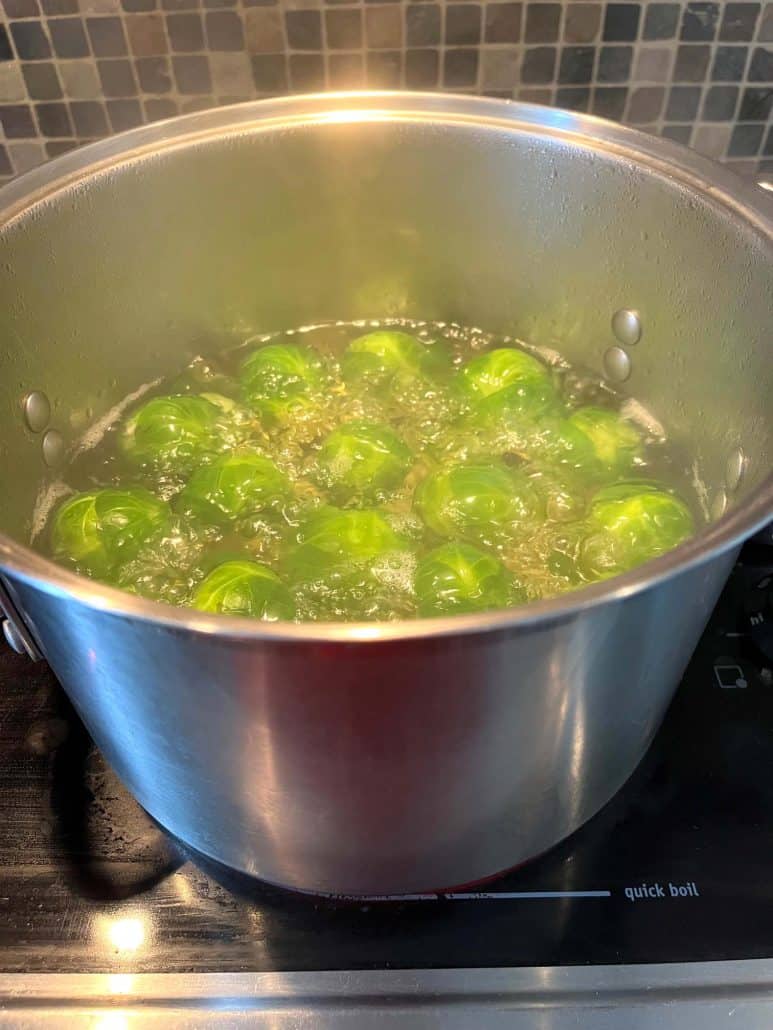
[239,343,323,411]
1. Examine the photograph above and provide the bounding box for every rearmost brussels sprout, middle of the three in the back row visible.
[341,330,447,386]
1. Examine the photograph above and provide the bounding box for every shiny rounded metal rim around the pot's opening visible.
[0,92,773,644]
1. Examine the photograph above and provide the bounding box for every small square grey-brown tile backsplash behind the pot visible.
[0,0,773,181]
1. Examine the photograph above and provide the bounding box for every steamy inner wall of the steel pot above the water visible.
[0,121,773,540]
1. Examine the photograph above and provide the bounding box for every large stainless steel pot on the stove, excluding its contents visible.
[0,94,773,893]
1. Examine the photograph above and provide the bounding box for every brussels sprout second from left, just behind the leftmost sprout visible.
[121,397,225,473]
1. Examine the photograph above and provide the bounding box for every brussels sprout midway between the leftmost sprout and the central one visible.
[175,454,291,523]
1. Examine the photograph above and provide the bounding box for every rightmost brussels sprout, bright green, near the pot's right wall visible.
[579,481,695,579]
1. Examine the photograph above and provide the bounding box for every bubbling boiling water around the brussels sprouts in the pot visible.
[36,321,702,621]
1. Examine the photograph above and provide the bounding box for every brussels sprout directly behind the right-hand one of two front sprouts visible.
[414,461,537,540]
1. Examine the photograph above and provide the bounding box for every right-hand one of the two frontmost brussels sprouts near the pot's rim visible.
[415,543,524,616]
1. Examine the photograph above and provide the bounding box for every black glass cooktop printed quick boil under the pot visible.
[0,548,773,974]
